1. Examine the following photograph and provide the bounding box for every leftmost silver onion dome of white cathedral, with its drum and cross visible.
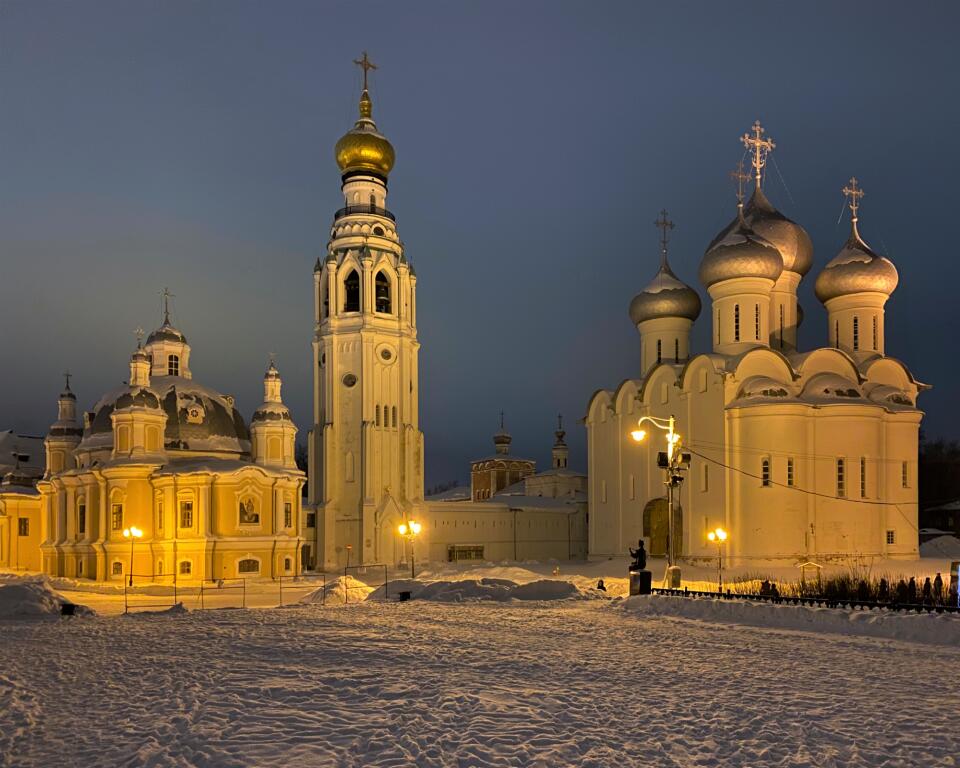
[630,210,700,376]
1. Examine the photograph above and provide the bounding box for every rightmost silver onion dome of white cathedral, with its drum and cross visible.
[815,178,899,360]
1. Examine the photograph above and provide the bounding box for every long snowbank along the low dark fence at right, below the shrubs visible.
[624,595,960,647]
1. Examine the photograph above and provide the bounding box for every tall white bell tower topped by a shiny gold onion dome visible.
[309,52,423,567]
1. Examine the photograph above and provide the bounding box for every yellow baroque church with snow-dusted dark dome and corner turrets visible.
[0,312,305,581]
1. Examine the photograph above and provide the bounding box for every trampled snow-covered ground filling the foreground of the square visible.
[0,568,960,766]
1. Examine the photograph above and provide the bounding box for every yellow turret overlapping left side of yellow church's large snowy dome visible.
[110,340,167,461]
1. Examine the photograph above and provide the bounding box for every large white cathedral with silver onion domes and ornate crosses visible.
[586,123,928,562]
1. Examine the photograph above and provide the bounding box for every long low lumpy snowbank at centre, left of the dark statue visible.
[368,578,583,603]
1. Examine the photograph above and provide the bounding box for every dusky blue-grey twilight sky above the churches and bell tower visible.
[0,0,960,485]
